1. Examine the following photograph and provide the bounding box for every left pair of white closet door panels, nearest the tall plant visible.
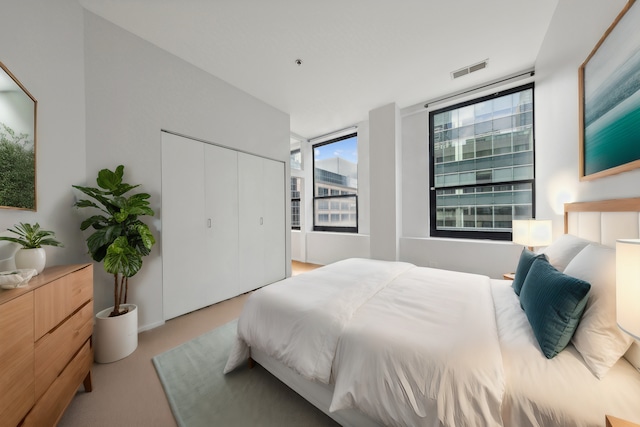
[161,133,240,319]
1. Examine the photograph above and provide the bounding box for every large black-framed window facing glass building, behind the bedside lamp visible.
[429,83,535,240]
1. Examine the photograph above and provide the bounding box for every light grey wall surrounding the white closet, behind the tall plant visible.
[85,12,291,329]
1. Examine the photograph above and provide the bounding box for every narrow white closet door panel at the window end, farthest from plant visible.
[262,159,291,284]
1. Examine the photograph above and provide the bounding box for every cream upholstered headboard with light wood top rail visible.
[564,197,640,369]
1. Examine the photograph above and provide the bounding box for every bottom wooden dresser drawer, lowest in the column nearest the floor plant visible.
[24,341,93,427]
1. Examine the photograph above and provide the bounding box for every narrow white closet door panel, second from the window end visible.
[238,153,264,293]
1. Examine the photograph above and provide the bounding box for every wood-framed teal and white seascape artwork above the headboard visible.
[578,0,640,180]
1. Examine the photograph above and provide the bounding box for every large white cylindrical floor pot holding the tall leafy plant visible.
[93,304,138,363]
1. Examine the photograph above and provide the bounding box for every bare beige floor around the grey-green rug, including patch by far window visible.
[58,261,319,427]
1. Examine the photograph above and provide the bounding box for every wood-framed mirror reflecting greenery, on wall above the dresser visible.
[0,62,38,211]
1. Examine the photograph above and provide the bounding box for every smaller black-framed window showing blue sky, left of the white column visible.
[313,133,358,233]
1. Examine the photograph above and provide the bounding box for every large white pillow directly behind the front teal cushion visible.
[565,243,633,379]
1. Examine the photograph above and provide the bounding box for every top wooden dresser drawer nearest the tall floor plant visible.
[34,264,93,340]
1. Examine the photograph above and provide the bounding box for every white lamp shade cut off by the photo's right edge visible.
[616,239,640,340]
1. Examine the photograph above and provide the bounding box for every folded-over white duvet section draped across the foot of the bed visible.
[225,259,414,384]
